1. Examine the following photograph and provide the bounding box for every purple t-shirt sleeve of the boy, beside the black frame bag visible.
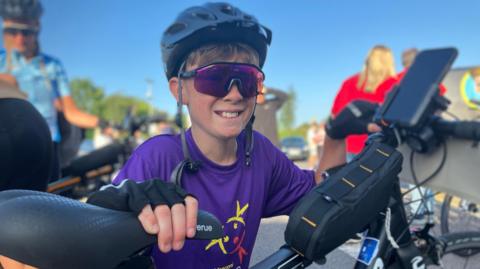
[262,146,315,217]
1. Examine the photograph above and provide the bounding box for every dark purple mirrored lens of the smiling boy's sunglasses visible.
[194,63,264,98]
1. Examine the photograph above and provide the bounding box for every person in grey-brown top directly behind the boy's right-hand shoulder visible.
[253,87,288,147]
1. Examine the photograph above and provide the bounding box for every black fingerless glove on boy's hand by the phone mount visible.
[325,100,378,139]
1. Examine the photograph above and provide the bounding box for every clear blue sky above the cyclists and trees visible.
[4,0,480,124]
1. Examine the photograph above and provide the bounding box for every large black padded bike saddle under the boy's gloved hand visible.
[0,190,223,269]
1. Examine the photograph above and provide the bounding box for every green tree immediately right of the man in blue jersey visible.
[70,78,105,116]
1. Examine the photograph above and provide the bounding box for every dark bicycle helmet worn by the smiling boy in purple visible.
[161,3,272,79]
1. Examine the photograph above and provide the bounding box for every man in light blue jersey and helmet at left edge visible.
[0,0,100,180]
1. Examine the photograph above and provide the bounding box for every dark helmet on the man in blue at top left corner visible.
[0,0,43,20]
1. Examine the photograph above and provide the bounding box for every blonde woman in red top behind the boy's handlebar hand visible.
[331,45,395,159]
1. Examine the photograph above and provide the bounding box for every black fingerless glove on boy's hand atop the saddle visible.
[87,179,192,214]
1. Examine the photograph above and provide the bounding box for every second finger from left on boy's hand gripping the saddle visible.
[153,205,173,253]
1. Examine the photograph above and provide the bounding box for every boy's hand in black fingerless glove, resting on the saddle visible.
[87,179,198,253]
